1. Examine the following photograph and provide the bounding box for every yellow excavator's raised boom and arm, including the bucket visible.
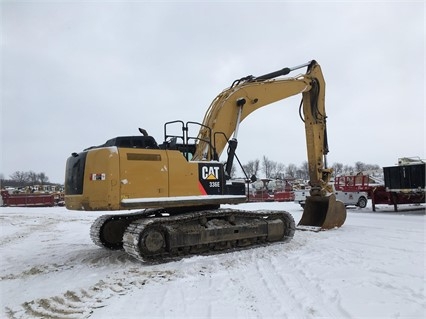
[194,60,346,229]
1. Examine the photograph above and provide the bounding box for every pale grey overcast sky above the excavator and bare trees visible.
[0,0,426,182]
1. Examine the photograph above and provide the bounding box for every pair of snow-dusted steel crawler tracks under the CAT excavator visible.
[90,209,296,262]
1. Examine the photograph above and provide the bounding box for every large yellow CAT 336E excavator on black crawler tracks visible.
[65,60,346,261]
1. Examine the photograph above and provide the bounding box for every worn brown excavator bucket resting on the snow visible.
[297,194,346,231]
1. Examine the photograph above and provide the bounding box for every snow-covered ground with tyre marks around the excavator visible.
[0,203,426,319]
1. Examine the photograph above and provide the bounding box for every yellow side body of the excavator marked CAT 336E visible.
[65,146,246,210]
